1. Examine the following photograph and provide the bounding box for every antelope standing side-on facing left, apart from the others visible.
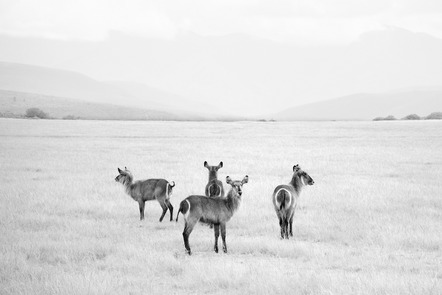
[115,167,175,222]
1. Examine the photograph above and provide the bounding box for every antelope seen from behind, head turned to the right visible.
[273,164,315,239]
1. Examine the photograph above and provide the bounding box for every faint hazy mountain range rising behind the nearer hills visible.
[0,28,442,115]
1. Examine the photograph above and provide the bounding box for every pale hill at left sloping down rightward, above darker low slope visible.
[0,62,230,120]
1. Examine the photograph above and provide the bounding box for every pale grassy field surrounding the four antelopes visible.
[0,119,442,294]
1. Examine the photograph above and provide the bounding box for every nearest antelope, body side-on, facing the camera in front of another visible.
[176,175,249,255]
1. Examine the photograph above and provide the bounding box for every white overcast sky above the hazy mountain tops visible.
[0,0,442,46]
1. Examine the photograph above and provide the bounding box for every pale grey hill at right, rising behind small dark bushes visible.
[271,87,442,121]
